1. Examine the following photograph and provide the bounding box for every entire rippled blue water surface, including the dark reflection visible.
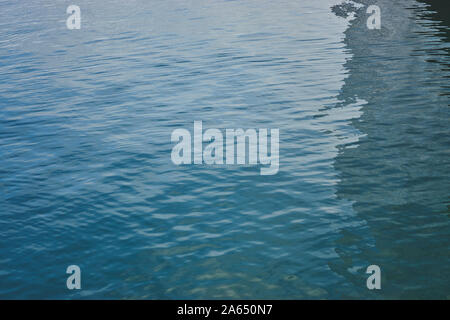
[0,0,450,299]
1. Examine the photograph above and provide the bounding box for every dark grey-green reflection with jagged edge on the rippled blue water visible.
[332,1,450,299]
